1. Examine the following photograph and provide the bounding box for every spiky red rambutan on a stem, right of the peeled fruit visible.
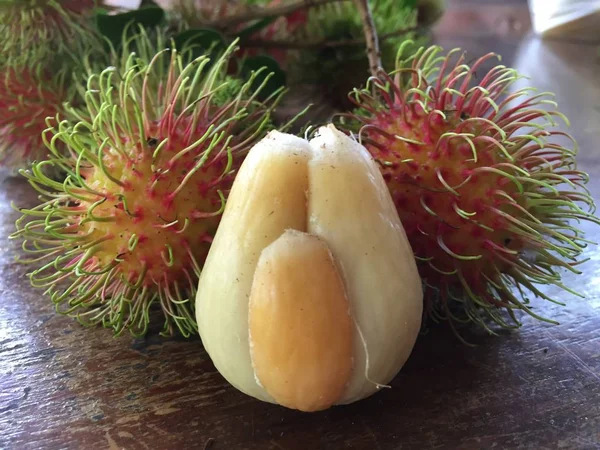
[340,46,598,338]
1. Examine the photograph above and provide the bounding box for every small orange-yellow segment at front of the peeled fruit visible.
[249,230,353,411]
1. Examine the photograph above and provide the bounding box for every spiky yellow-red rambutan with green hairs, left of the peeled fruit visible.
[12,41,279,336]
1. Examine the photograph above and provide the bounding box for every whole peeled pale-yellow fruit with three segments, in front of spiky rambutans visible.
[196,126,423,411]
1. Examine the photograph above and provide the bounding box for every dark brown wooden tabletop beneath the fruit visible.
[0,1,600,450]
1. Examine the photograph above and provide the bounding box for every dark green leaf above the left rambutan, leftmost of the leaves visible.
[96,6,165,47]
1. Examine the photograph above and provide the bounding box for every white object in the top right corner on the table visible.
[528,0,600,42]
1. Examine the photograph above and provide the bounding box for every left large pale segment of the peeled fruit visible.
[196,132,311,401]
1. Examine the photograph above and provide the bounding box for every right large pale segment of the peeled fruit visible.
[308,127,423,403]
